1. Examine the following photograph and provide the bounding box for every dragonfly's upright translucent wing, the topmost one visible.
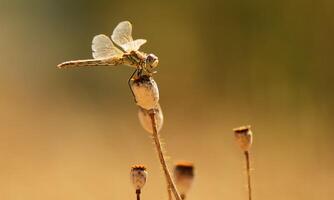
[111,21,133,48]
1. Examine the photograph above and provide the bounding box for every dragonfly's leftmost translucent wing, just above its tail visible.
[92,34,123,59]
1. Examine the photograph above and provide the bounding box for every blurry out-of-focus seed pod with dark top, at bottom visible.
[174,162,194,199]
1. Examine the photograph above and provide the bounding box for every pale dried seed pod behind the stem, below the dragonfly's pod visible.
[138,103,164,134]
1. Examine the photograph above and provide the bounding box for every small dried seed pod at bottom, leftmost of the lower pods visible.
[130,165,147,190]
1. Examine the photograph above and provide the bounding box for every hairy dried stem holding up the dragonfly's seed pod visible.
[150,111,182,200]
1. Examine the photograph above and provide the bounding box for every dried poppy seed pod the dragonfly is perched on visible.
[131,75,159,110]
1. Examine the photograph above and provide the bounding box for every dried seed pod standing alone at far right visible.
[233,126,253,151]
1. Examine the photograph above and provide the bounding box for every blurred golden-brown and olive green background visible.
[0,0,334,200]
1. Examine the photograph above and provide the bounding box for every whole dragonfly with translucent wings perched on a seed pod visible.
[57,21,159,84]
